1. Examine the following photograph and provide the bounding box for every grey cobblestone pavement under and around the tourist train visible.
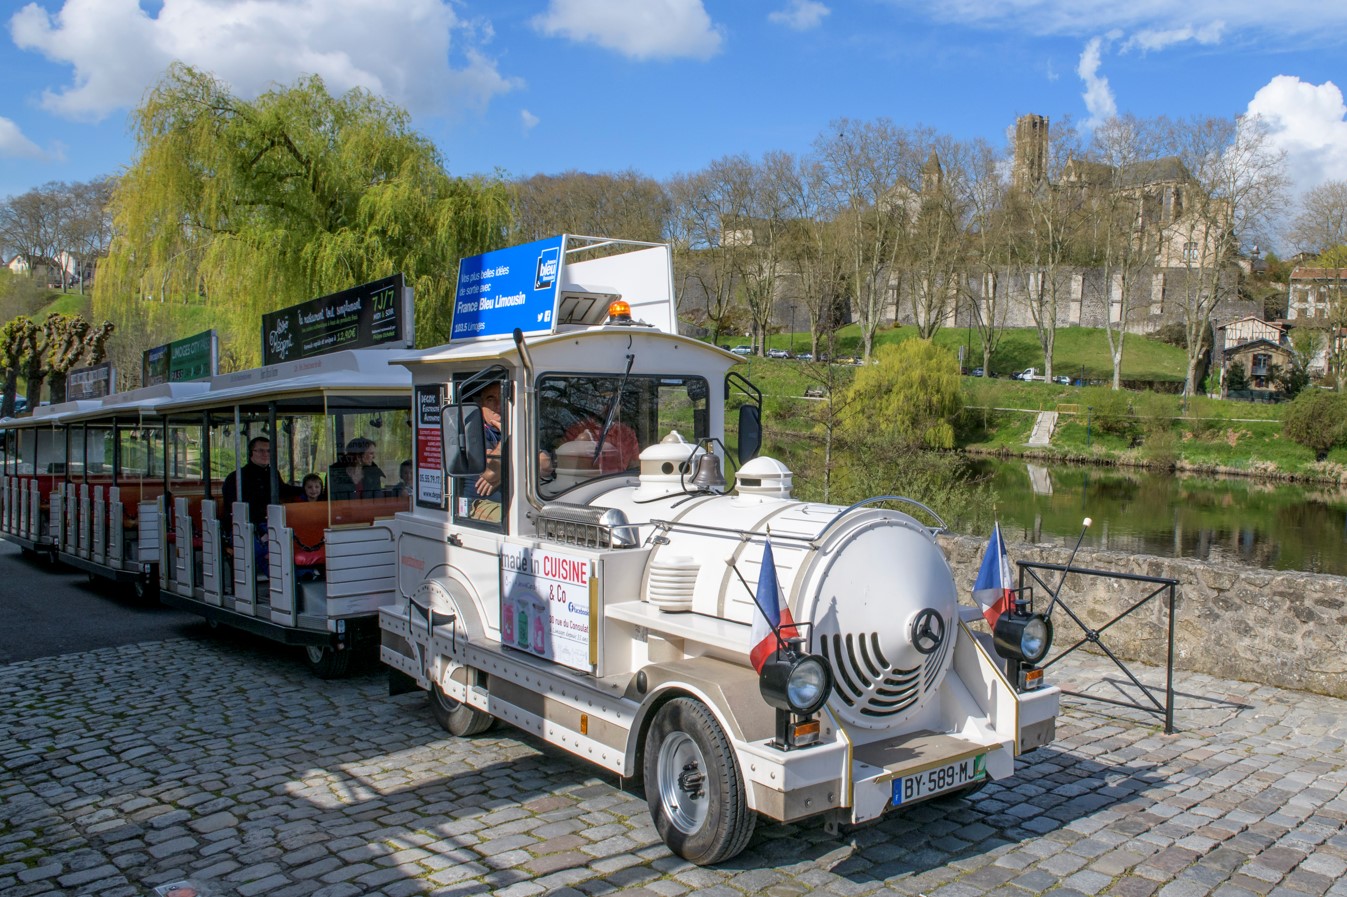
[0,627,1347,897]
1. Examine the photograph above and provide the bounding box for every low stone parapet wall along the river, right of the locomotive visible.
[940,536,1347,698]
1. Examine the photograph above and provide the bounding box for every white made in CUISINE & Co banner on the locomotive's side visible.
[501,543,594,671]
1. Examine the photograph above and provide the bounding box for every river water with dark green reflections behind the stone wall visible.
[951,459,1347,575]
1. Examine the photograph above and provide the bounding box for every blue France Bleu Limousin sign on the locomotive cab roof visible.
[450,237,562,341]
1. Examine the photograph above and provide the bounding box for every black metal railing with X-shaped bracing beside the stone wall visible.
[1017,560,1179,735]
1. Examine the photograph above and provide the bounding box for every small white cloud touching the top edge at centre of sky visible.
[532,0,723,61]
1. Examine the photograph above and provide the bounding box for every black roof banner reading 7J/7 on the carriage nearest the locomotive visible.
[261,273,412,365]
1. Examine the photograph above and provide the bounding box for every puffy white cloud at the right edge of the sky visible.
[1249,75,1347,193]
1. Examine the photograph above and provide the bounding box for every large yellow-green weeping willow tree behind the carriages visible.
[94,63,509,370]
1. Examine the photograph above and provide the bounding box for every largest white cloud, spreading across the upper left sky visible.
[9,0,520,120]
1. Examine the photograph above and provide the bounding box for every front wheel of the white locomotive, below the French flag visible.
[641,698,757,866]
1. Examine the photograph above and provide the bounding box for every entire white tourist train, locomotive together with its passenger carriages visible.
[0,236,1059,865]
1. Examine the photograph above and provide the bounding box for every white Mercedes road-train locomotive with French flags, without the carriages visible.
[380,237,1059,863]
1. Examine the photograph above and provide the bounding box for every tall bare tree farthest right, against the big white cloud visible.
[1165,116,1288,396]
